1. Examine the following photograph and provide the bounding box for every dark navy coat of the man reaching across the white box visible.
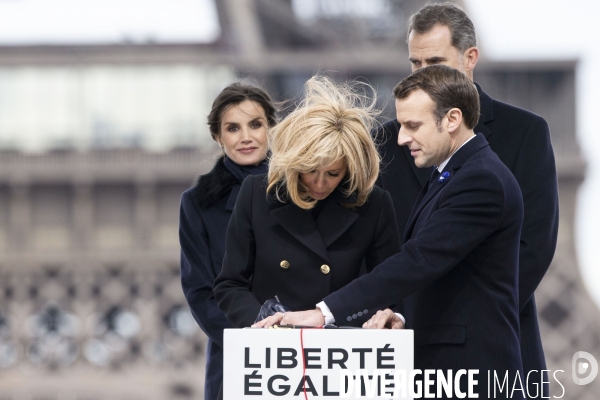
[324,135,523,398]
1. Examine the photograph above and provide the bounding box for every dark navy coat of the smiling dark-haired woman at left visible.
[179,157,255,400]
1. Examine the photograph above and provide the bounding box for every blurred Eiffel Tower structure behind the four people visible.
[0,0,600,400]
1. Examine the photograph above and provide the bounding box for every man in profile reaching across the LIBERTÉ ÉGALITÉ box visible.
[282,66,523,398]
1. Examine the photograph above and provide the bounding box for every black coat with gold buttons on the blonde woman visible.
[214,175,400,327]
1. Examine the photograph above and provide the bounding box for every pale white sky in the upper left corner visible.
[0,0,220,45]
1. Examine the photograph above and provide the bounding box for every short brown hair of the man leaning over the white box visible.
[394,65,479,129]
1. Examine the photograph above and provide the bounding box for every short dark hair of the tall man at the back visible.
[406,3,477,53]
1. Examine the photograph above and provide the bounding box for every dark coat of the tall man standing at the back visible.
[377,85,558,393]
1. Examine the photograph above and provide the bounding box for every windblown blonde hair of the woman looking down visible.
[267,76,380,209]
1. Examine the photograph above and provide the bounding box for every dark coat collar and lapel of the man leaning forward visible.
[404,133,489,242]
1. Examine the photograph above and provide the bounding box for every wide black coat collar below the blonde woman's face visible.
[267,184,358,262]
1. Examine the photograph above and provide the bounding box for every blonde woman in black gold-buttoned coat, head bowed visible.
[214,77,400,327]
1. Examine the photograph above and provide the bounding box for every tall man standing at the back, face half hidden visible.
[378,3,558,397]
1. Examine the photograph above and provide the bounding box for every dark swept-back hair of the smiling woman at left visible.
[208,82,277,140]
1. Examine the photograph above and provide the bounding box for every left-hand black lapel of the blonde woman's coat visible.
[270,202,329,261]
